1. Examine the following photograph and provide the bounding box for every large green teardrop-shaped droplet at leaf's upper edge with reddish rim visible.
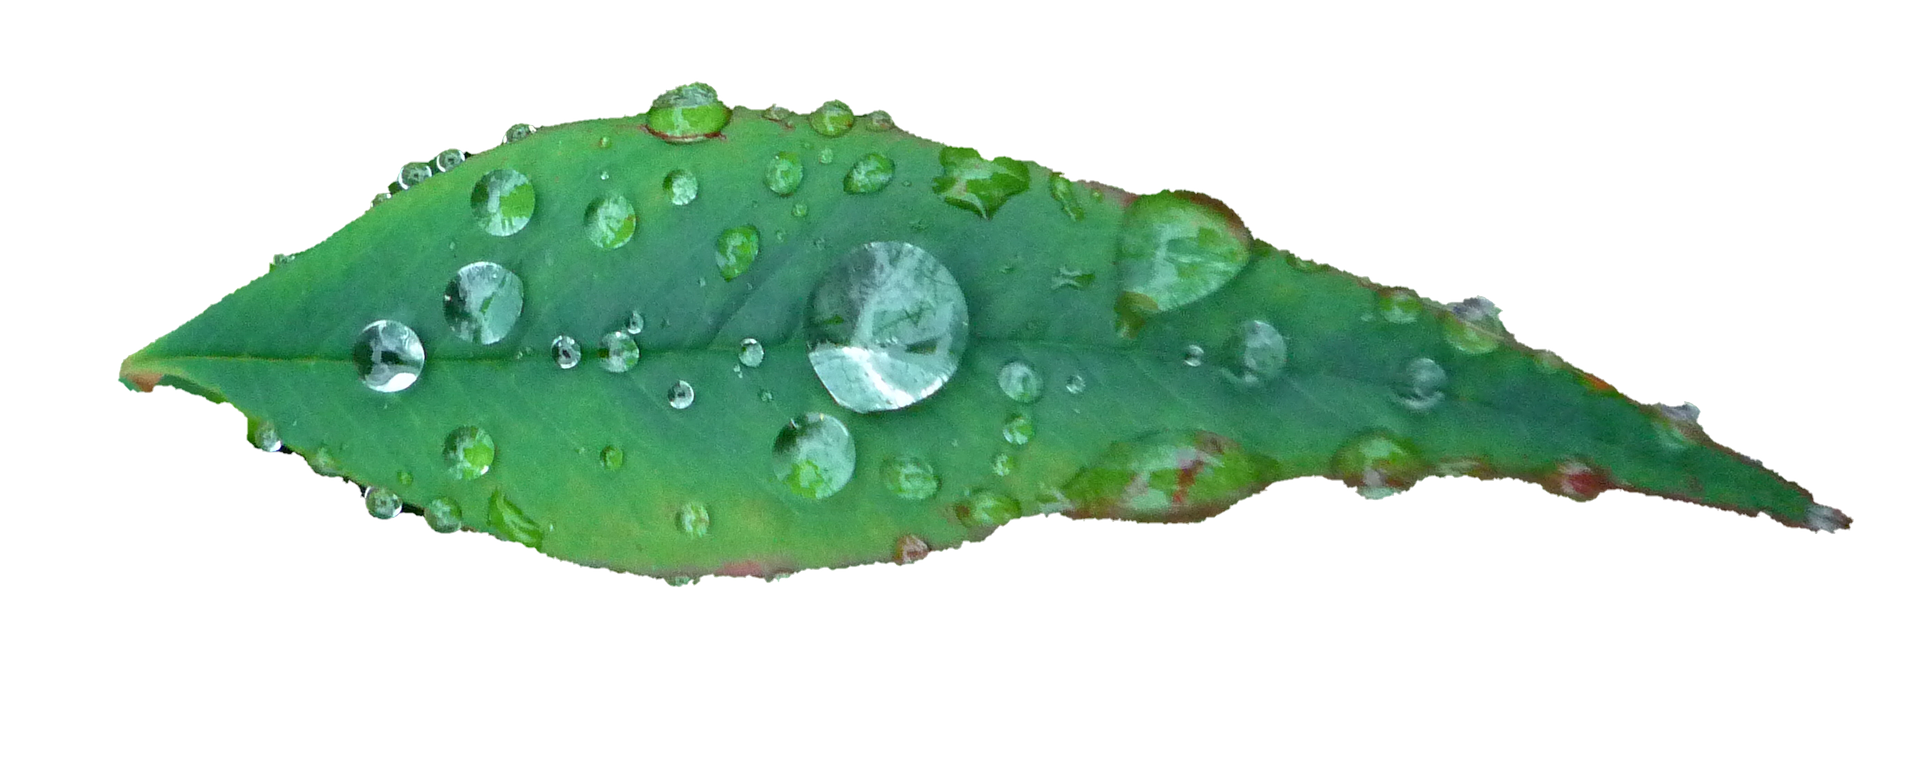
[1116,190,1252,338]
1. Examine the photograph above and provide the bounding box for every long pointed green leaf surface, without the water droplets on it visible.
[112,83,1850,576]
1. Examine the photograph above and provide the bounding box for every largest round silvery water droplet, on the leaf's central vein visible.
[806,242,968,413]
